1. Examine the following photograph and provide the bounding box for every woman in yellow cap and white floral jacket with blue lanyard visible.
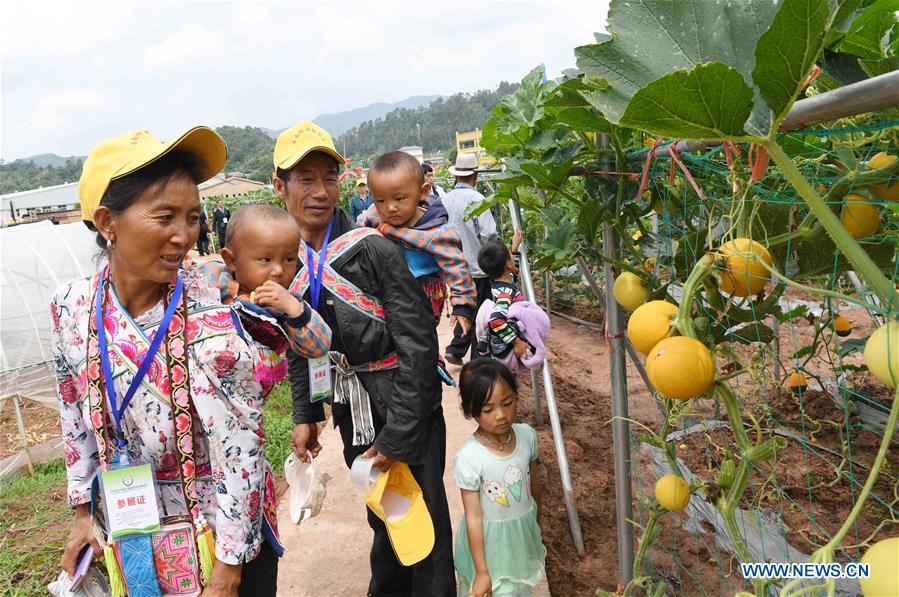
[51,127,281,597]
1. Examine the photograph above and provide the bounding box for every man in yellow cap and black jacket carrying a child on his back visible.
[273,121,456,596]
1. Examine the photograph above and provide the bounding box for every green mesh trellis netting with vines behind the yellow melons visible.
[631,120,899,595]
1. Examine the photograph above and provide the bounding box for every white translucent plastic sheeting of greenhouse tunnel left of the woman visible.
[0,221,98,405]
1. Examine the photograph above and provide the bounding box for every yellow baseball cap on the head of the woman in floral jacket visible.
[78,126,228,222]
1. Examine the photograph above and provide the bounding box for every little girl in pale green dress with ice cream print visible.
[453,358,546,597]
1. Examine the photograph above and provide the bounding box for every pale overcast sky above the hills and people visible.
[0,0,608,161]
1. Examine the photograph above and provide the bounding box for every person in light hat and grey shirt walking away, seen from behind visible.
[443,153,496,365]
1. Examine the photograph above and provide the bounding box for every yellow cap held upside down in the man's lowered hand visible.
[365,462,434,566]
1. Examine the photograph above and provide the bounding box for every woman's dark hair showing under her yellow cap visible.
[84,150,206,250]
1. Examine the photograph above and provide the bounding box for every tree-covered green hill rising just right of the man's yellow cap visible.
[335,81,518,160]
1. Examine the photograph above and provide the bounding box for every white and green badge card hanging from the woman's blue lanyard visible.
[100,464,159,539]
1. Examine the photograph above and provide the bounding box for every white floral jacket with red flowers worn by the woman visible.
[51,269,275,564]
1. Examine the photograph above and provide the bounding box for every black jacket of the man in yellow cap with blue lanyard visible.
[287,209,442,464]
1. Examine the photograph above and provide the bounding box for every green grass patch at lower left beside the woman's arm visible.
[0,460,72,596]
